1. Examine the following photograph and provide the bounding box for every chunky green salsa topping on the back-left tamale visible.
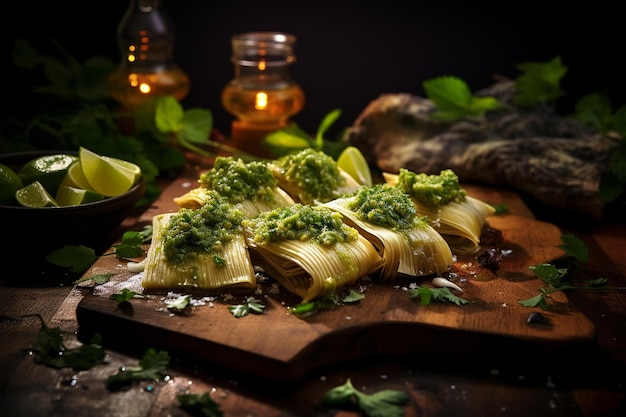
[198,156,278,203]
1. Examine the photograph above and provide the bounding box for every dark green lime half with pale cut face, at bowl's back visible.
[17,154,78,194]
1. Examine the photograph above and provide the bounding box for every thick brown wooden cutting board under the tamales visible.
[76,165,595,381]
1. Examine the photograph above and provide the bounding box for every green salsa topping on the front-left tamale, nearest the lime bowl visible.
[163,191,244,266]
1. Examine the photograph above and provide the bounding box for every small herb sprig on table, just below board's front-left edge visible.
[105,348,170,389]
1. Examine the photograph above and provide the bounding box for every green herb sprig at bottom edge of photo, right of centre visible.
[322,378,409,417]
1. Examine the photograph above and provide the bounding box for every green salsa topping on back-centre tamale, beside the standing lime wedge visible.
[278,148,346,202]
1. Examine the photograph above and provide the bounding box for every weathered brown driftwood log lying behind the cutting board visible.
[344,81,614,221]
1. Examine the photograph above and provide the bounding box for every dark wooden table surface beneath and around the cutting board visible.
[0,154,626,417]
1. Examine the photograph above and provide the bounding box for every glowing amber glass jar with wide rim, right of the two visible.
[222,32,304,157]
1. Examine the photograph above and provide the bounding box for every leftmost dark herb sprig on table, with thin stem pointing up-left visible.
[25,314,105,371]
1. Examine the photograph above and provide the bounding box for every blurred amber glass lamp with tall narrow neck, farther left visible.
[108,0,189,111]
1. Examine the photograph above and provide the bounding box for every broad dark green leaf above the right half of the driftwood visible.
[513,56,567,107]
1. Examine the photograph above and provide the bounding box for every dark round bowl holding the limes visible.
[0,151,145,258]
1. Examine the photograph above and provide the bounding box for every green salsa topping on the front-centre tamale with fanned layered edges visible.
[245,204,359,246]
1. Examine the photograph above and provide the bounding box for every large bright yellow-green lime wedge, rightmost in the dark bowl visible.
[78,147,141,197]
